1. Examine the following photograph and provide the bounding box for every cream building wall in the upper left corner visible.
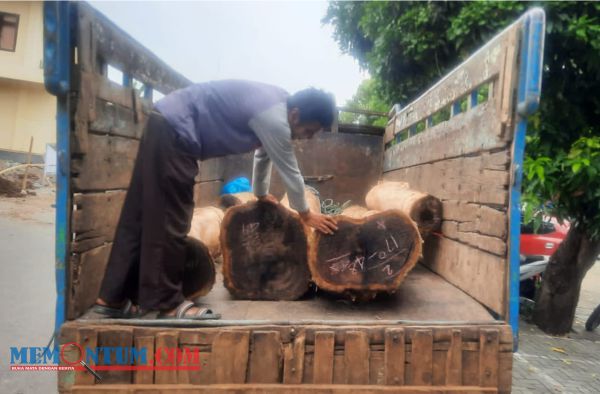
[0,2,56,154]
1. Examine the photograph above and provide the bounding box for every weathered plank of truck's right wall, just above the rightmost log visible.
[383,149,509,206]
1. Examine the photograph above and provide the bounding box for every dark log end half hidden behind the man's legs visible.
[182,237,216,299]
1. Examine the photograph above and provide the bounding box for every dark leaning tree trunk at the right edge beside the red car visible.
[533,226,600,335]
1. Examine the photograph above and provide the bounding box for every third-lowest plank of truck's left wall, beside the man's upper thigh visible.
[71,134,139,192]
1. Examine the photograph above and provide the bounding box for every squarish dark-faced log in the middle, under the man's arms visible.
[221,201,310,300]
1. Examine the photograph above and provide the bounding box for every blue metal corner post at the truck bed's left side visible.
[44,1,72,346]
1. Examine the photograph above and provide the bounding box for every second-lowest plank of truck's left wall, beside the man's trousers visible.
[71,191,126,252]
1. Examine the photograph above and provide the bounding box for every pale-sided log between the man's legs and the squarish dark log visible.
[188,207,224,258]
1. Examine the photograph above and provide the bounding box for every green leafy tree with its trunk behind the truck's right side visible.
[324,2,600,334]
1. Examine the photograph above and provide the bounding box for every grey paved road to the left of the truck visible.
[0,195,56,394]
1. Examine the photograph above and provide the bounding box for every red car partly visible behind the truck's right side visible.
[521,218,569,256]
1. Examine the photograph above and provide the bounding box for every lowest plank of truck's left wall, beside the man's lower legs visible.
[67,244,112,319]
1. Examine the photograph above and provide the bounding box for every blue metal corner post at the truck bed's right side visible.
[508,8,546,351]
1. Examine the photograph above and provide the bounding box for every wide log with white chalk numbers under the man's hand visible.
[309,207,422,300]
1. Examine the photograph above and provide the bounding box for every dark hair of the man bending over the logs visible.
[287,88,335,128]
